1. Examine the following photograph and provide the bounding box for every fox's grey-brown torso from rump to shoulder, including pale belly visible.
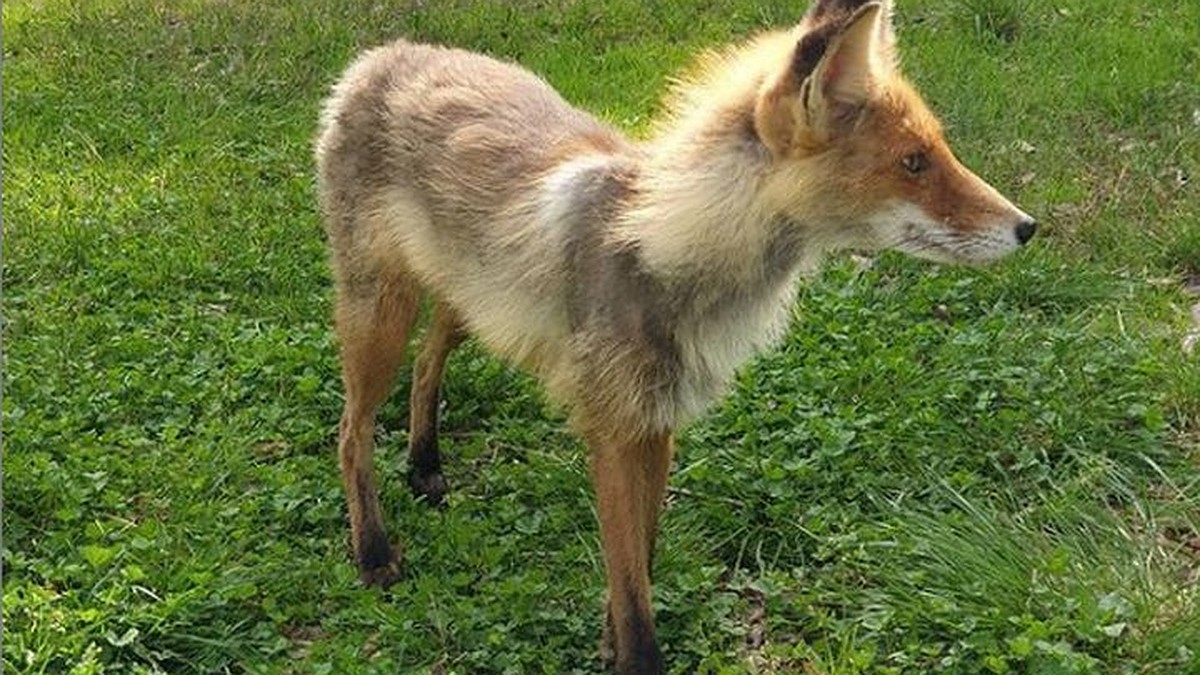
[317,41,630,379]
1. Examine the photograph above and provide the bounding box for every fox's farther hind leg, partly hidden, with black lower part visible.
[408,303,466,506]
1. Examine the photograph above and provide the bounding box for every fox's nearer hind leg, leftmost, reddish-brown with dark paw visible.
[335,266,420,586]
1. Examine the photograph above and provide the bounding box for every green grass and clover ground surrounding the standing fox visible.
[2,0,1200,674]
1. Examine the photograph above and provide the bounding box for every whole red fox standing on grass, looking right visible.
[314,0,1037,675]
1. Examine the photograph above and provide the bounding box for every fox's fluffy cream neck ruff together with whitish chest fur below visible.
[604,117,820,423]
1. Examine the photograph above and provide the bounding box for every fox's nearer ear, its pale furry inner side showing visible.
[800,2,892,123]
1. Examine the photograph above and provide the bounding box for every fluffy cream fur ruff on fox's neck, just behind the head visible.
[618,112,841,294]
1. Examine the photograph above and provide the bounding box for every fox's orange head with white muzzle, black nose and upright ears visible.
[754,0,1037,263]
